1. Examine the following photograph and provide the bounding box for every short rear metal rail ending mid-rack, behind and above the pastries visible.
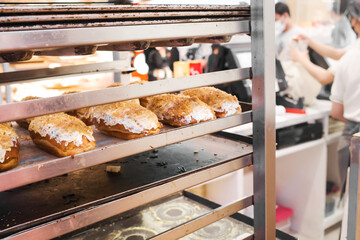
[0,61,135,85]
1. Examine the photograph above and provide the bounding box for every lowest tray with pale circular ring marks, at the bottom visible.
[55,191,296,240]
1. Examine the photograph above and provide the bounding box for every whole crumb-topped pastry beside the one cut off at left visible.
[29,113,95,157]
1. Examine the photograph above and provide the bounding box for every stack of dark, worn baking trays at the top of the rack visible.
[0,5,250,31]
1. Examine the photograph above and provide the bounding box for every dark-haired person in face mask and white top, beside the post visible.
[275,2,304,61]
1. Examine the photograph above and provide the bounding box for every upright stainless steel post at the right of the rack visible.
[251,0,276,240]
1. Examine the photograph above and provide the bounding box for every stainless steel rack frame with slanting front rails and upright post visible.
[0,0,275,240]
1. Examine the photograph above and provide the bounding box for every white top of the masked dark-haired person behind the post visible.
[275,26,304,61]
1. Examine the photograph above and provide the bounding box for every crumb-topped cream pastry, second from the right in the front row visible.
[140,94,216,127]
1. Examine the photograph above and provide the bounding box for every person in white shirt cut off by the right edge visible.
[330,1,360,199]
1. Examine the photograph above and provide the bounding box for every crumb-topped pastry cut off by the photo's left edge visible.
[0,123,20,172]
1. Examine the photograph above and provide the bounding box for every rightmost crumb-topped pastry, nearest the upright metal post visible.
[182,87,242,118]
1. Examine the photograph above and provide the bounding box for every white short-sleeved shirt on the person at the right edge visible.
[330,44,360,122]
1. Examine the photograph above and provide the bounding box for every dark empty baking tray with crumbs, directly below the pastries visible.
[0,135,252,237]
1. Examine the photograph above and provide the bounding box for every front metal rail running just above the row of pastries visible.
[0,68,251,122]
